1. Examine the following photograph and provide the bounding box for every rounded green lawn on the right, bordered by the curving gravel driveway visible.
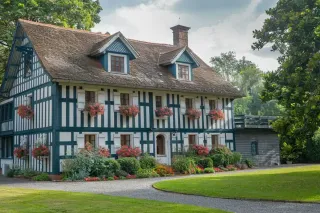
[154,165,320,202]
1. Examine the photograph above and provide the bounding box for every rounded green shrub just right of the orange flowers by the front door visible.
[172,156,196,174]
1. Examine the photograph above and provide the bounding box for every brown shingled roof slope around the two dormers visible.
[19,20,242,97]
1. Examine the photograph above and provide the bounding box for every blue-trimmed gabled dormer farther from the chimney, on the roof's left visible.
[90,32,139,74]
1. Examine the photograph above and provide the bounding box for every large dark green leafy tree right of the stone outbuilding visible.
[252,0,320,161]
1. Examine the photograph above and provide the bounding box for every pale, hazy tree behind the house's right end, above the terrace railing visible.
[211,51,281,115]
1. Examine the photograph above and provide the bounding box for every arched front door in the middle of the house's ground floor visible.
[156,134,170,165]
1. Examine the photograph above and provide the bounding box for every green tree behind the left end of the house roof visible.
[0,0,102,83]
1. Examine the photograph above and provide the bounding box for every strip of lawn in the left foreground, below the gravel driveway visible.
[0,187,225,213]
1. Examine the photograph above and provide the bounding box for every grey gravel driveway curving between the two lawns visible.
[0,169,320,213]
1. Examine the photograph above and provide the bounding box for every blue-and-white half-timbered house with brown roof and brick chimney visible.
[0,20,241,174]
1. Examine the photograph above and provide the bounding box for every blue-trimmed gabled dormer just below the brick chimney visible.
[159,46,200,81]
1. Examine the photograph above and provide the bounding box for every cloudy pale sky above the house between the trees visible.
[92,0,278,71]
